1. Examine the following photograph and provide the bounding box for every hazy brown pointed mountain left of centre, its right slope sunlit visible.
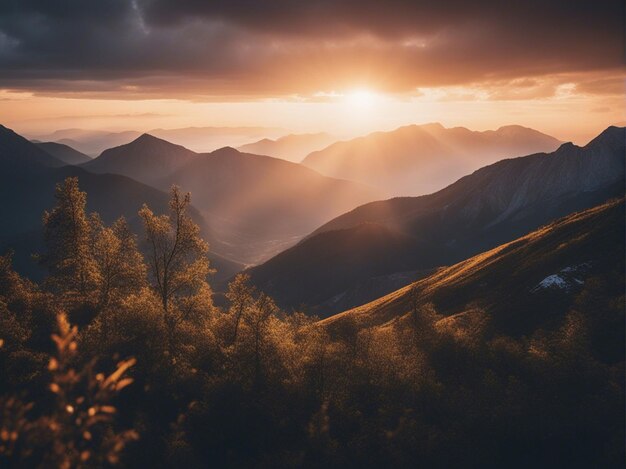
[76,134,380,264]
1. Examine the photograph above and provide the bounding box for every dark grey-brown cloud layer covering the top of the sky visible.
[0,0,624,96]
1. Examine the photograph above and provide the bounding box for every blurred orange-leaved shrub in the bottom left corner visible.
[0,314,138,468]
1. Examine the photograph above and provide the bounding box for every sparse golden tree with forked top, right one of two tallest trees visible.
[139,186,212,344]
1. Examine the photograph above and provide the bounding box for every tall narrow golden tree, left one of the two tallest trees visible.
[40,177,99,306]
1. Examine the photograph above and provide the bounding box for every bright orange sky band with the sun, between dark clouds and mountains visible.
[0,71,626,144]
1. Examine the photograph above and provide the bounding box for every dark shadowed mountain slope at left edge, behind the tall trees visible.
[0,126,241,279]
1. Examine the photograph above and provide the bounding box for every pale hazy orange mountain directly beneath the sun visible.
[303,124,561,196]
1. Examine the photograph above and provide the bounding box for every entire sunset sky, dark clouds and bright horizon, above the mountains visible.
[0,0,626,143]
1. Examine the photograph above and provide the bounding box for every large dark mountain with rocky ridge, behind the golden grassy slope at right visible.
[249,127,626,315]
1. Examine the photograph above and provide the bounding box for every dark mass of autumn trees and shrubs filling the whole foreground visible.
[0,179,624,468]
